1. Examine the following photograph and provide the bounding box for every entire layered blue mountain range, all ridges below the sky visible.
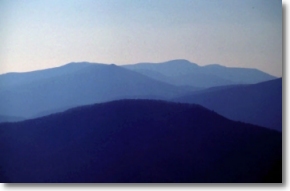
[0,60,283,183]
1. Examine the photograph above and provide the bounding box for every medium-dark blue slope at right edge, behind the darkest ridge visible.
[174,78,282,131]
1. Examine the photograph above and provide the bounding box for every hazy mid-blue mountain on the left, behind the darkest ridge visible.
[0,63,188,118]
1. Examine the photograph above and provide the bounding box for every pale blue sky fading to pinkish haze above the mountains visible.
[0,0,283,77]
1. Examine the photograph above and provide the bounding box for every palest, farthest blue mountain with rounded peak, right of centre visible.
[123,60,275,87]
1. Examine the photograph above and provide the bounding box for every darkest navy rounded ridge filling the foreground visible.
[0,100,282,183]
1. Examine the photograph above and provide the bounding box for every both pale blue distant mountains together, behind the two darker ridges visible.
[0,60,274,125]
